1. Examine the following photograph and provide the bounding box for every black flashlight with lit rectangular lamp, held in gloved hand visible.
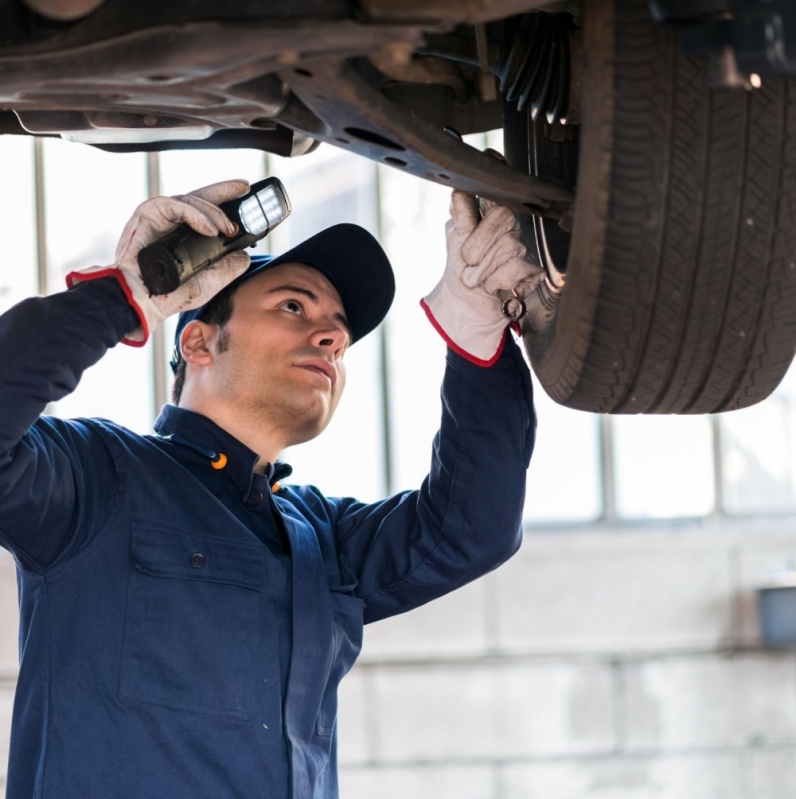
[138,178,292,295]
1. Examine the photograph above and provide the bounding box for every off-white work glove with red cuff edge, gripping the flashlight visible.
[66,180,249,347]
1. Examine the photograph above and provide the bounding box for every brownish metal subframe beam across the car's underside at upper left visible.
[0,20,422,128]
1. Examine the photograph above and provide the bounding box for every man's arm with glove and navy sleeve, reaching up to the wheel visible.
[320,192,543,621]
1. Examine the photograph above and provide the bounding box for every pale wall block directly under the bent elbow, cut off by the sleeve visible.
[360,580,487,662]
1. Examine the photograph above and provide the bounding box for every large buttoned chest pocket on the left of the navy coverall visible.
[119,524,262,721]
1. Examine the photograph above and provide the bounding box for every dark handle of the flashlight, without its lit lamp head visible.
[138,225,258,295]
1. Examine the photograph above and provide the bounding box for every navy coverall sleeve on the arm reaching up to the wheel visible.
[336,337,536,622]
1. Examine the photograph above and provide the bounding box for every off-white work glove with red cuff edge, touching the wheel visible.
[420,191,544,366]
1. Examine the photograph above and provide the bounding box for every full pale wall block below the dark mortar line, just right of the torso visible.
[373,663,615,763]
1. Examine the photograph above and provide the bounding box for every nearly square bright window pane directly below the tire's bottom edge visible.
[612,416,714,519]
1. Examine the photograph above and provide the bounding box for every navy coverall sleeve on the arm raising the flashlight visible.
[0,278,138,571]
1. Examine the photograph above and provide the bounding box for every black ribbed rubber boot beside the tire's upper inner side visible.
[492,12,572,125]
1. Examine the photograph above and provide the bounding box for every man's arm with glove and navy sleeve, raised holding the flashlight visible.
[0,181,248,571]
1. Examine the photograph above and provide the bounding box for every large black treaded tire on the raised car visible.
[505,0,796,413]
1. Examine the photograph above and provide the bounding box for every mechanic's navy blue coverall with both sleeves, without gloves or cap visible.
[0,278,535,799]
